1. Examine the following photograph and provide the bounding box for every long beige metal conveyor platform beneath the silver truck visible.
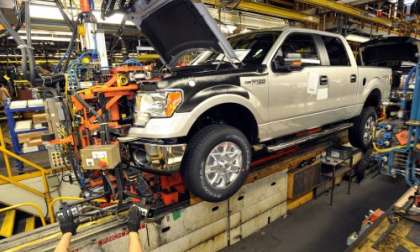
[0,131,347,252]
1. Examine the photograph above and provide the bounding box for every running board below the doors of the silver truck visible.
[267,123,353,152]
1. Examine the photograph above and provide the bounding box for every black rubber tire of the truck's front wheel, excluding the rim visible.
[182,125,251,202]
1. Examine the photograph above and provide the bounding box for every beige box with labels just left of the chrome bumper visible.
[80,144,121,170]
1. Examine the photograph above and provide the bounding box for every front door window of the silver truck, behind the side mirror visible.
[280,33,321,66]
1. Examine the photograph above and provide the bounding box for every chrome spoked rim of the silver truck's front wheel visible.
[204,141,243,189]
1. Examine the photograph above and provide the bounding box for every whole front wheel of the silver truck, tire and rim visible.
[182,125,251,202]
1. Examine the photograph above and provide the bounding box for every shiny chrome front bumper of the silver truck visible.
[130,141,187,173]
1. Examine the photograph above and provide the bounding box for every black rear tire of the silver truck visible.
[349,107,377,151]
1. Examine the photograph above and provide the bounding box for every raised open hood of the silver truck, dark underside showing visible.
[132,0,236,66]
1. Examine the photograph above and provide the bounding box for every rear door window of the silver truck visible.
[322,36,350,66]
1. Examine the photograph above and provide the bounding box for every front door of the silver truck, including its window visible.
[269,33,323,137]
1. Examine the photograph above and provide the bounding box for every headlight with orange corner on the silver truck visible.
[135,90,183,125]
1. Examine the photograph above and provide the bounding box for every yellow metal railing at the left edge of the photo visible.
[0,127,52,218]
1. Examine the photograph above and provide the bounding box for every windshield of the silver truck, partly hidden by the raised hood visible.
[181,31,281,66]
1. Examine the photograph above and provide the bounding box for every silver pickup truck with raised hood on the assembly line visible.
[126,0,391,201]
